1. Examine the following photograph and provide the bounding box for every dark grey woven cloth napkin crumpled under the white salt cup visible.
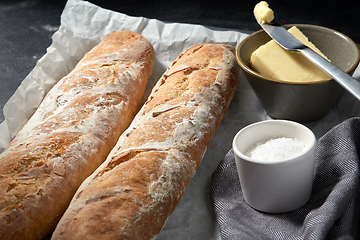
[211,118,360,240]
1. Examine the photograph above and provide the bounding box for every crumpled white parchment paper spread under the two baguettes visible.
[0,0,360,240]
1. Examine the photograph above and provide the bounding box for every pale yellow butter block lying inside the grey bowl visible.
[250,26,331,83]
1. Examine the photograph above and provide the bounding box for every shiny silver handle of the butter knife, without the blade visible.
[299,48,360,101]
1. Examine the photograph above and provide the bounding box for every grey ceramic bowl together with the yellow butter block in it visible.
[236,24,360,123]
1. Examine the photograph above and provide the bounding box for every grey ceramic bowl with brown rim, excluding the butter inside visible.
[236,24,360,122]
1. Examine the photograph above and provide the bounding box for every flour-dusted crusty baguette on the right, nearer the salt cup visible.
[52,44,240,240]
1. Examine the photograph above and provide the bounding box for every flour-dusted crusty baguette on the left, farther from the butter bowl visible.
[0,31,155,240]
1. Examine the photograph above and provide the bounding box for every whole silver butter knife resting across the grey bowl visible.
[258,20,360,101]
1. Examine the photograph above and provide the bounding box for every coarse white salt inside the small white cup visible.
[245,137,305,162]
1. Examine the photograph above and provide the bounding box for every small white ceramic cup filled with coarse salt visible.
[233,120,316,213]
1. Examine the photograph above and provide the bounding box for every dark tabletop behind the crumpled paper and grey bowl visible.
[0,0,360,123]
